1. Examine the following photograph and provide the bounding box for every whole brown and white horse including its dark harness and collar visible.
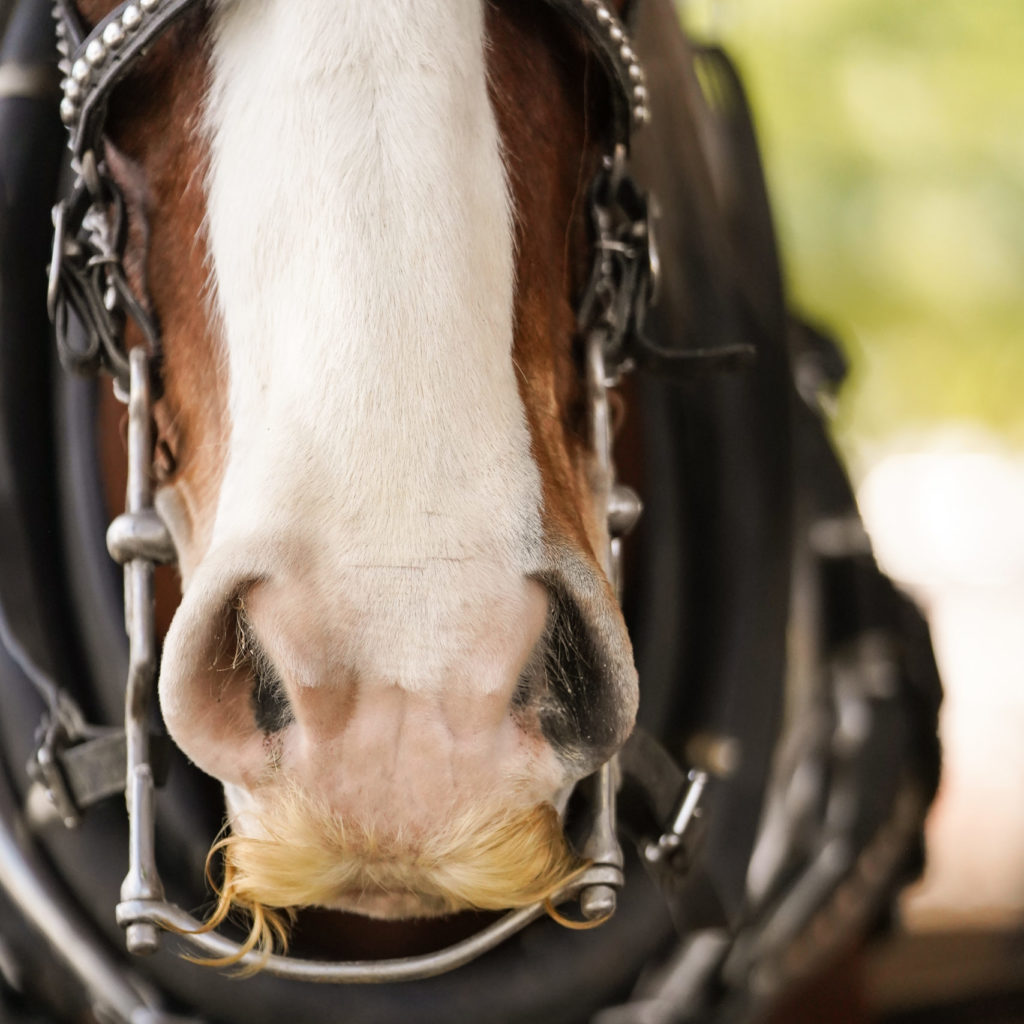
[0,0,936,1020]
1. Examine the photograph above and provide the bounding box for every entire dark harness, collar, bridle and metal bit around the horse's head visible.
[0,0,938,1021]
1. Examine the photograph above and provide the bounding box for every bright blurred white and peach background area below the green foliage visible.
[858,426,1024,929]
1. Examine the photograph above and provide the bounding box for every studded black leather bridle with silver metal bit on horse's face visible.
[37,0,712,982]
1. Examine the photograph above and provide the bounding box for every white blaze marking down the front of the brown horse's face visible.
[206,0,542,689]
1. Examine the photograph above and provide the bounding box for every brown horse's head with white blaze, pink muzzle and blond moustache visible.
[66,0,637,918]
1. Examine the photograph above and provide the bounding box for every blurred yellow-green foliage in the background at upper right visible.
[690,0,1024,449]
